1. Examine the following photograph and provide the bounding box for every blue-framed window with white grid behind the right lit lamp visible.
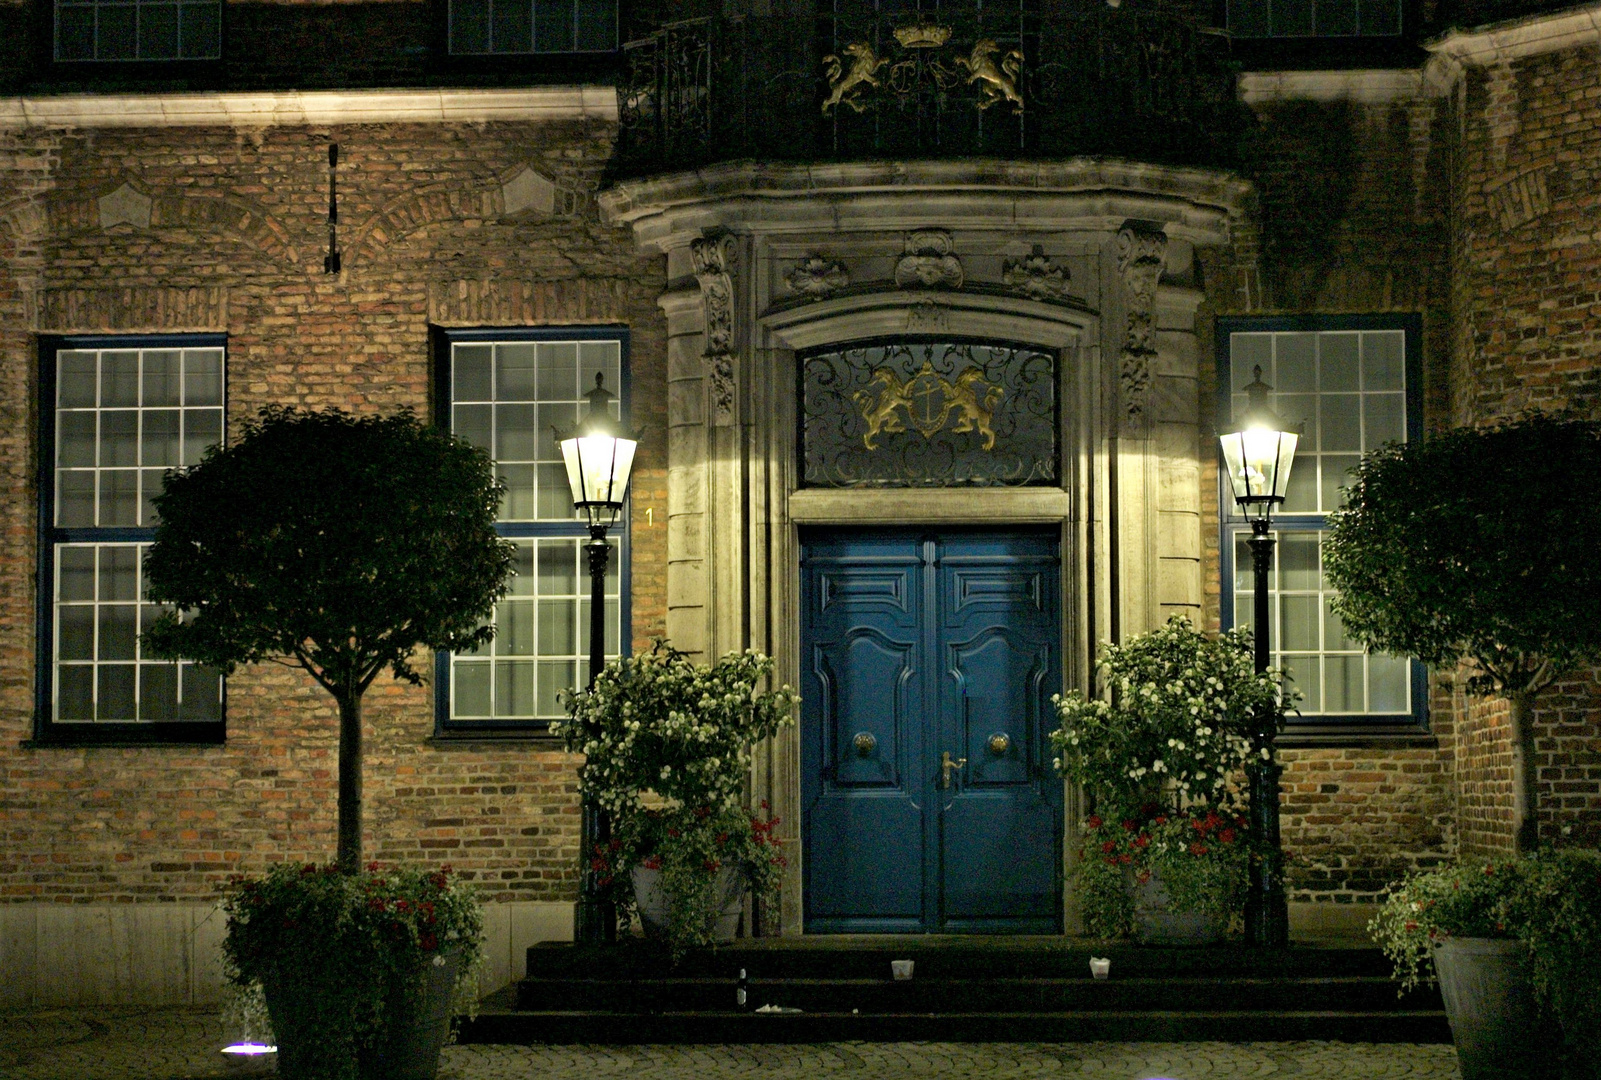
[1217,315,1428,734]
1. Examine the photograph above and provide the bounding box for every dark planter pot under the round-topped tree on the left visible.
[263,949,461,1080]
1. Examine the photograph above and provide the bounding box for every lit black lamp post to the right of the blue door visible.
[1220,366,1300,949]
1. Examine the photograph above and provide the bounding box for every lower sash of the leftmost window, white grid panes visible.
[51,542,223,723]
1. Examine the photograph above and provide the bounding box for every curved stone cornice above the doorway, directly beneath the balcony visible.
[597,158,1250,251]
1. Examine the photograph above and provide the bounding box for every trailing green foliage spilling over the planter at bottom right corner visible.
[1367,848,1601,1062]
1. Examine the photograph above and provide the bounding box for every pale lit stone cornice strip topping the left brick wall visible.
[0,86,616,130]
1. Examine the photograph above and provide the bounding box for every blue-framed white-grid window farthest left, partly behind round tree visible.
[35,334,226,744]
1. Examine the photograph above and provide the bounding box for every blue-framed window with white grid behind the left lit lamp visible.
[434,326,629,736]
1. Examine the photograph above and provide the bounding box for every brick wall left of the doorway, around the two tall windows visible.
[0,122,666,902]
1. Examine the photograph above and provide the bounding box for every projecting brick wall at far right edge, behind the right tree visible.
[1451,45,1601,854]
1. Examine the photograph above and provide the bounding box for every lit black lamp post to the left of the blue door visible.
[556,373,639,942]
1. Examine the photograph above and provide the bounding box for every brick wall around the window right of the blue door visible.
[1201,99,1455,902]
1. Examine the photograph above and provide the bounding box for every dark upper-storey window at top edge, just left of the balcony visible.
[450,0,618,56]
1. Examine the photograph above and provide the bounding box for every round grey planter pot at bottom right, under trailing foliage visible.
[1434,938,1561,1080]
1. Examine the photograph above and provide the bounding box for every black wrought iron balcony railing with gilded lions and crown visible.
[616,0,1246,176]
